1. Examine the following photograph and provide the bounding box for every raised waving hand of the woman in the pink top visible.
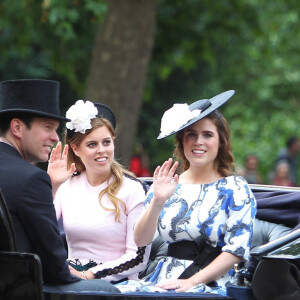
[47,142,76,194]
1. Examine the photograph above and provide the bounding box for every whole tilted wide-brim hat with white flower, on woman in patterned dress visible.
[157,90,235,140]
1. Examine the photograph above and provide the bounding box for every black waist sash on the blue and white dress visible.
[168,236,222,279]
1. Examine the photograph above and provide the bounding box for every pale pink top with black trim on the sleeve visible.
[54,172,150,281]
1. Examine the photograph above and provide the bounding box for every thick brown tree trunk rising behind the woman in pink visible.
[84,0,156,165]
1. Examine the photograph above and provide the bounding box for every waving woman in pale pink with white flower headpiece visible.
[48,100,150,283]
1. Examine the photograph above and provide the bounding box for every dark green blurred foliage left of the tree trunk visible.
[0,0,107,95]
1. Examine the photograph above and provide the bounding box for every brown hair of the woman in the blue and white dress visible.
[174,110,234,177]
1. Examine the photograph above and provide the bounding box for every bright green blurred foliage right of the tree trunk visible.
[139,0,300,183]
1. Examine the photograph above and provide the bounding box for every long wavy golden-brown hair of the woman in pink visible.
[65,117,135,222]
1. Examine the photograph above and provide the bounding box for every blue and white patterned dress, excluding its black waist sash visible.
[116,175,256,296]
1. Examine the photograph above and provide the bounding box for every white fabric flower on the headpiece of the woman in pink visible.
[66,100,98,133]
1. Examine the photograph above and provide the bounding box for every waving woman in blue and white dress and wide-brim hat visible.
[134,91,256,296]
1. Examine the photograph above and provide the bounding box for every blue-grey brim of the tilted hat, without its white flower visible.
[157,90,235,140]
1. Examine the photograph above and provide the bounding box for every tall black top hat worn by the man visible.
[0,79,69,122]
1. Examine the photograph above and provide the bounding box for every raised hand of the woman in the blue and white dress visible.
[153,158,178,206]
